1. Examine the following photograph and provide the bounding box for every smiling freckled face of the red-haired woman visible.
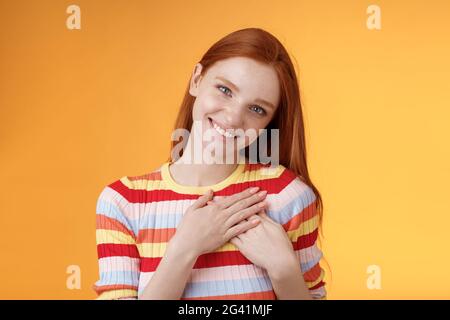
[189,57,280,160]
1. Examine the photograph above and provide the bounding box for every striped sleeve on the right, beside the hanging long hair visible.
[284,178,327,300]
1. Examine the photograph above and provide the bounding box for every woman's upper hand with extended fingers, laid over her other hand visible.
[169,187,267,257]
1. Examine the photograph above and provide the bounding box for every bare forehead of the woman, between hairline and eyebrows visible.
[205,57,279,105]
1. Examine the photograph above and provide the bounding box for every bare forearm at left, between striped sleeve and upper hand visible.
[139,236,197,300]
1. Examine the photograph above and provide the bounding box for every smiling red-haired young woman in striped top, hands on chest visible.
[94,28,326,299]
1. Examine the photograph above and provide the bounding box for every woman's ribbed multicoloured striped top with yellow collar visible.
[93,162,326,300]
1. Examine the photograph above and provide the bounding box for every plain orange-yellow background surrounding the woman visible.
[0,0,450,299]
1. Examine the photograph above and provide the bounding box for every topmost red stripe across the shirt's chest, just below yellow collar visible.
[109,166,296,203]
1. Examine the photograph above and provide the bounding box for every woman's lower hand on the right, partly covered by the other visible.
[230,210,296,274]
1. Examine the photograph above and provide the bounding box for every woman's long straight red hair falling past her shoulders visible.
[168,28,323,280]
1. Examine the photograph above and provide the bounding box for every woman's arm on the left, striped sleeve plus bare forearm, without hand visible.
[94,188,197,300]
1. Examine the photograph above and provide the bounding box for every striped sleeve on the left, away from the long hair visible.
[93,186,140,300]
